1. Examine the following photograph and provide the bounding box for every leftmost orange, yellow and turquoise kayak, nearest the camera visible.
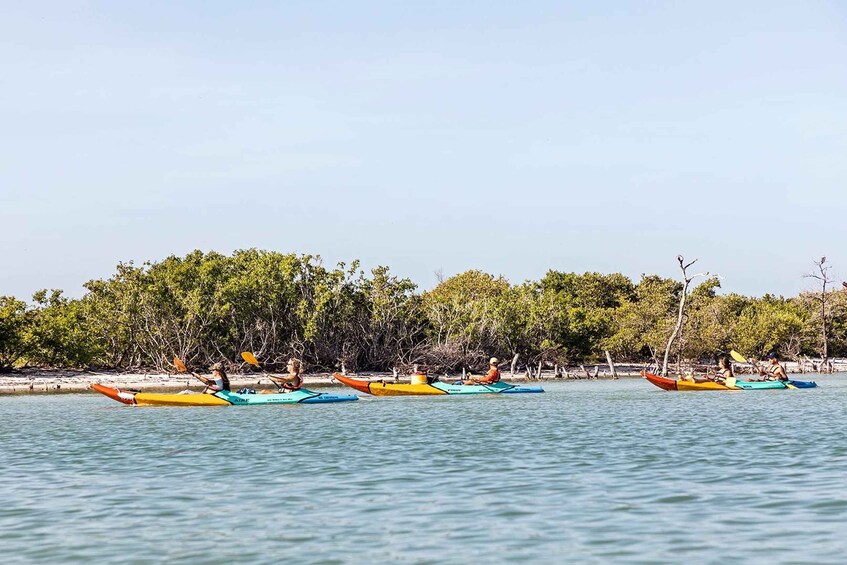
[91,384,359,406]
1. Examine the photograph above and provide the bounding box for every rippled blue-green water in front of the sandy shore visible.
[0,376,847,563]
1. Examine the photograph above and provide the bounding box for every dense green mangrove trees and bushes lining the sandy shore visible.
[0,249,847,371]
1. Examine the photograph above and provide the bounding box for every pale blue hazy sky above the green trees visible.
[0,0,847,299]
